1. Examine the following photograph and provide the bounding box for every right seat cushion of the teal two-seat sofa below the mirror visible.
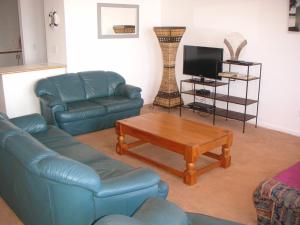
[90,96,143,113]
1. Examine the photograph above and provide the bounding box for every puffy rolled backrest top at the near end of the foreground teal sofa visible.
[38,155,101,193]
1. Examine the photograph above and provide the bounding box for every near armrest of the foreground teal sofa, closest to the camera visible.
[96,168,160,197]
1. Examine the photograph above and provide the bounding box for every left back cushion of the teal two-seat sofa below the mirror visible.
[47,73,86,102]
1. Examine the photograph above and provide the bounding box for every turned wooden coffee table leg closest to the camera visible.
[183,151,198,185]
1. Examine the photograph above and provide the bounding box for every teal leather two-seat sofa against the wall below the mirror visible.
[35,71,143,135]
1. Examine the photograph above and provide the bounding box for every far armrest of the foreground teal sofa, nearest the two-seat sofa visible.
[10,113,48,134]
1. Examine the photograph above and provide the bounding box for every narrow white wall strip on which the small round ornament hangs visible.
[44,0,66,64]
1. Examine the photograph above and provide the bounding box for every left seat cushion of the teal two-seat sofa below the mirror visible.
[56,100,107,123]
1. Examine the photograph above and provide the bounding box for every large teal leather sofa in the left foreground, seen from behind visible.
[0,114,168,225]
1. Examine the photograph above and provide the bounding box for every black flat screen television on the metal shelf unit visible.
[183,45,223,81]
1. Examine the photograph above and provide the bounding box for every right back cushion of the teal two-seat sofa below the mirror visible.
[78,71,125,99]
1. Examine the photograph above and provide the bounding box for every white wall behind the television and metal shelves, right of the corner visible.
[162,0,300,136]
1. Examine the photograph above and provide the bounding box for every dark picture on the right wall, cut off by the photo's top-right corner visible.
[289,0,300,32]
